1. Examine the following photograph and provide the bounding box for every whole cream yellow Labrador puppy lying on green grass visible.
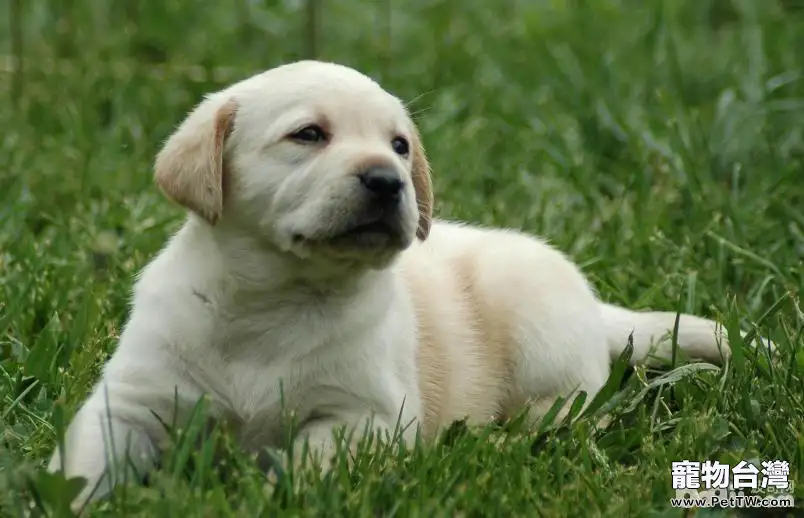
[50,61,740,506]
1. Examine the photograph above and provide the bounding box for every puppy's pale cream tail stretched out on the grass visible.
[601,303,731,365]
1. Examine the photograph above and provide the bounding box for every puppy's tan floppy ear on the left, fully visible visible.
[154,97,237,225]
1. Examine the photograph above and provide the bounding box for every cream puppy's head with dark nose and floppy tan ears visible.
[155,61,433,270]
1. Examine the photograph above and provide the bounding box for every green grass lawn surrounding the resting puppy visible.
[0,0,804,517]
